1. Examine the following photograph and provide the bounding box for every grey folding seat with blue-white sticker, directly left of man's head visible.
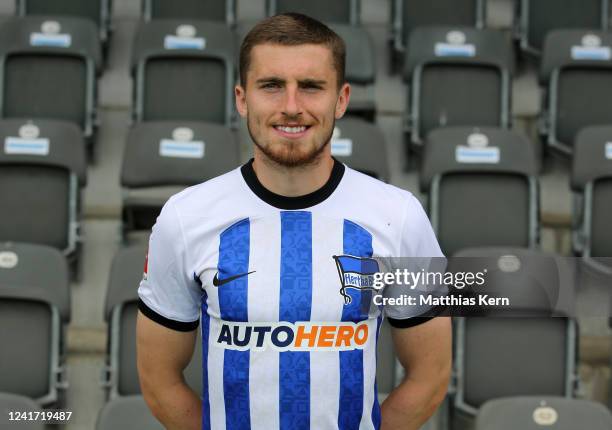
[132,20,236,125]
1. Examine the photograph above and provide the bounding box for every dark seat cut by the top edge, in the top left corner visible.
[17,0,112,43]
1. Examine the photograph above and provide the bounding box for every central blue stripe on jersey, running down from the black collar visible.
[279,211,312,430]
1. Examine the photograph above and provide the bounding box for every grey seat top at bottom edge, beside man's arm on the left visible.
[96,395,164,430]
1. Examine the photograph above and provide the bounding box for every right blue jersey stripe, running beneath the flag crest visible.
[338,220,373,430]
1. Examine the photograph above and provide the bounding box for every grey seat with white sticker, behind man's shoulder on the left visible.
[121,122,240,242]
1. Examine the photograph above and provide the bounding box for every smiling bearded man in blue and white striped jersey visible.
[137,14,451,430]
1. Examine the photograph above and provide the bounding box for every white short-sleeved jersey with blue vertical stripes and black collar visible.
[139,161,442,430]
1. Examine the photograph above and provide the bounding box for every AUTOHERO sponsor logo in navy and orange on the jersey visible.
[215,321,370,351]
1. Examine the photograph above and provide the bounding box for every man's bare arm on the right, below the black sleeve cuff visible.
[381,317,452,430]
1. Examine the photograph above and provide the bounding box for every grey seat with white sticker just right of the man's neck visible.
[331,116,390,182]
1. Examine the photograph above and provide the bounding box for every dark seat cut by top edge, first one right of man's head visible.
[390,0,486,70]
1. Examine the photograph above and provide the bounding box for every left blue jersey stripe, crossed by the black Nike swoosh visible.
[217,218,251,430]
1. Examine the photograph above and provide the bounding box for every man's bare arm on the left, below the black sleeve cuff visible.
[136,311,202,430]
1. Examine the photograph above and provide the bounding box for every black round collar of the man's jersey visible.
[240,158,344,210]
